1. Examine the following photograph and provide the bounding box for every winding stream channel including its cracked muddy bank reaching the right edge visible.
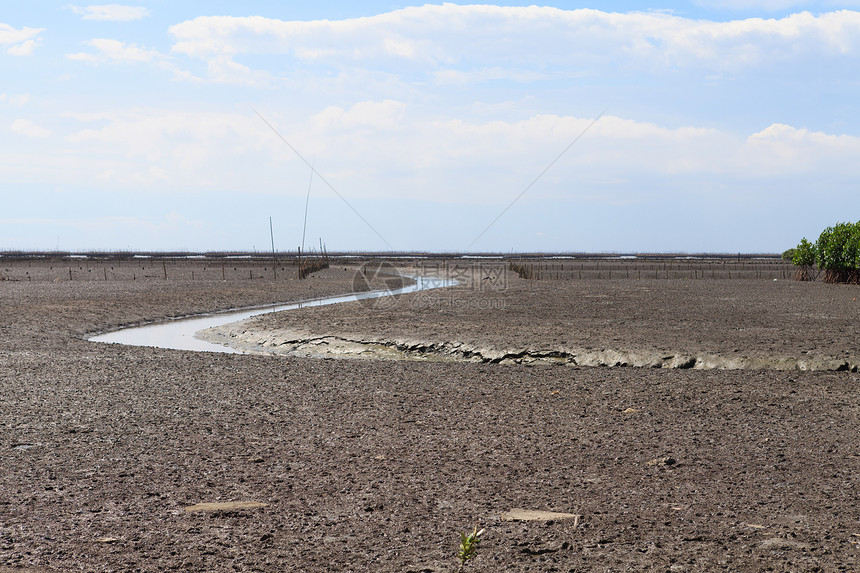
[88,275,860,372]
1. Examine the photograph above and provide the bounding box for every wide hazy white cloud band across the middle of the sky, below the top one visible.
[6,98,848,209]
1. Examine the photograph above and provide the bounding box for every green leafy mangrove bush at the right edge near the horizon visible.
[791,222,860,284]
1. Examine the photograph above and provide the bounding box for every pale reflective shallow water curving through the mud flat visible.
[89,276,456,354]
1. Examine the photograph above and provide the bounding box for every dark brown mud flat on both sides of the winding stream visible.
[0,260,860,573]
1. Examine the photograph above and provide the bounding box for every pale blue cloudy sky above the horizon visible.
[0,0,860,253]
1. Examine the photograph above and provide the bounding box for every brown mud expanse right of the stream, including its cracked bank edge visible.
[227,265,860,370]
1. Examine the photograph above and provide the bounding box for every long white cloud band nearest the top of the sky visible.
[170,4,860,82]
